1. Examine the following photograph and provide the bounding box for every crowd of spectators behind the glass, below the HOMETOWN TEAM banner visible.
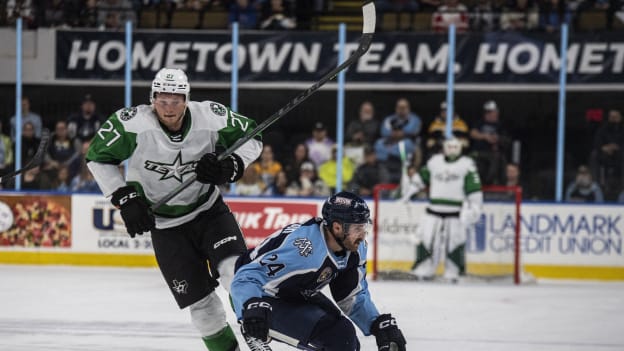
[0,94,624,202]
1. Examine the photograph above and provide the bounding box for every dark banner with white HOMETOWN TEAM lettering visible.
[55,30,624,85]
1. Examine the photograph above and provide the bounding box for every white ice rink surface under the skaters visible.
[0,265,624,351]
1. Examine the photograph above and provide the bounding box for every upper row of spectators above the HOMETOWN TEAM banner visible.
[0,0,624,33]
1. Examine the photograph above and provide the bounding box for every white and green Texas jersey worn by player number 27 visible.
[86,101,262,228]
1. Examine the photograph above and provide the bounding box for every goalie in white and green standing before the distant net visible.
[401,138,483,282]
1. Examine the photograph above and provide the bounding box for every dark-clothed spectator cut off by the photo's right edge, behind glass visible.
[590,110,624,201]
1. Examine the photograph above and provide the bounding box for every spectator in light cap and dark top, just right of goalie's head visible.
[470,100,511,185]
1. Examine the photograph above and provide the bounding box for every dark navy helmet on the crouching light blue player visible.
[321,191,370,225]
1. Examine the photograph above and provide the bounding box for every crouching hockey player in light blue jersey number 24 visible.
[230,192,406,351]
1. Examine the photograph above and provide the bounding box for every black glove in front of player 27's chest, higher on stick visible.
[195,152,245,185]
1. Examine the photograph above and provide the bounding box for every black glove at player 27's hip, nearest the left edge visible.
[111,186,156,238]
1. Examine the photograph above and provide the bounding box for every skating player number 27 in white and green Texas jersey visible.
[86,68,262,351]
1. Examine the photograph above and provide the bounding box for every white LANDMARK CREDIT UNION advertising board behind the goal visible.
[379,201,624,280]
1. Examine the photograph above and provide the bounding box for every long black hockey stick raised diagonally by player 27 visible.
[151,0,376,211]
